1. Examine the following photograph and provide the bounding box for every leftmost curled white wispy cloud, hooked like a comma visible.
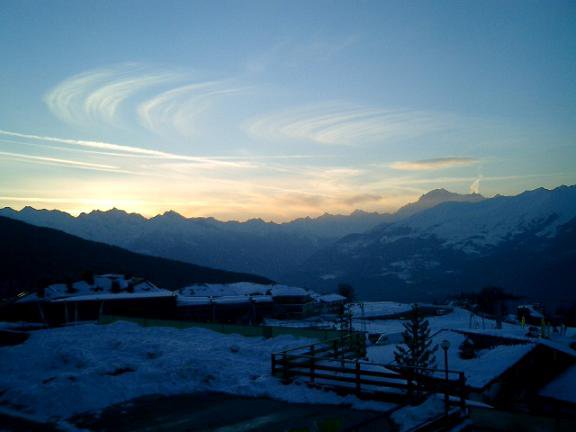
[44,64,183,126]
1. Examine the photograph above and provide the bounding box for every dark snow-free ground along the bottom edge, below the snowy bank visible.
[0,394,390,432]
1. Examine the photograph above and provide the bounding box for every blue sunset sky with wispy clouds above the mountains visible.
[0,0,576,221]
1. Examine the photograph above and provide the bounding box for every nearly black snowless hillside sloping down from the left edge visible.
[0,217,272,298]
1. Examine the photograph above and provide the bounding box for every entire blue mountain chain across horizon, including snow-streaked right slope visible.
[0,186,576,301]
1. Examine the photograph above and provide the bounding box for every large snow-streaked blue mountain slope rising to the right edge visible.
[290,186,576,303]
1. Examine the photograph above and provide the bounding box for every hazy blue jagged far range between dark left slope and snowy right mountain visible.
[0,189,483,279]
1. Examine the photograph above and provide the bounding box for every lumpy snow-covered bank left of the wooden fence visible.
[0,322,390,421]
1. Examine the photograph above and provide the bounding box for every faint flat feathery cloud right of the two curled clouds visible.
[246,102,455,145]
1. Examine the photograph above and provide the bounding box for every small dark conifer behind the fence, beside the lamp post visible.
[394,305,438,369]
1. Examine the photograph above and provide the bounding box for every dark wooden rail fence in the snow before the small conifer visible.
[272,337,467,409]
